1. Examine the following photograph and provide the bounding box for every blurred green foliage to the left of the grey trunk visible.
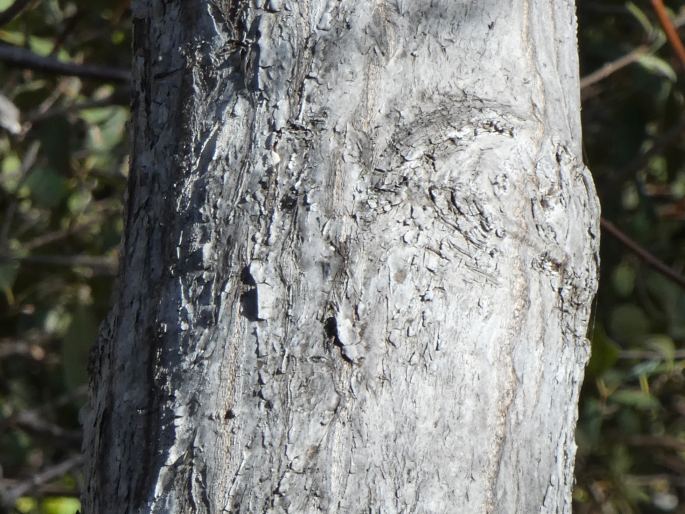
[0,0,130,508]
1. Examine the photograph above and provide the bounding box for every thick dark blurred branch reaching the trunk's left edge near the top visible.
[0,45,131,82]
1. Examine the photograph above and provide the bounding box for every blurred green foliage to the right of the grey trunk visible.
[574,0,685,513]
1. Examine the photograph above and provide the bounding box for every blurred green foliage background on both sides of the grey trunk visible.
[0,0,685,514]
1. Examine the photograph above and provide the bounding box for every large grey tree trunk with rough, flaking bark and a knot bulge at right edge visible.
[83,0,599,514]
